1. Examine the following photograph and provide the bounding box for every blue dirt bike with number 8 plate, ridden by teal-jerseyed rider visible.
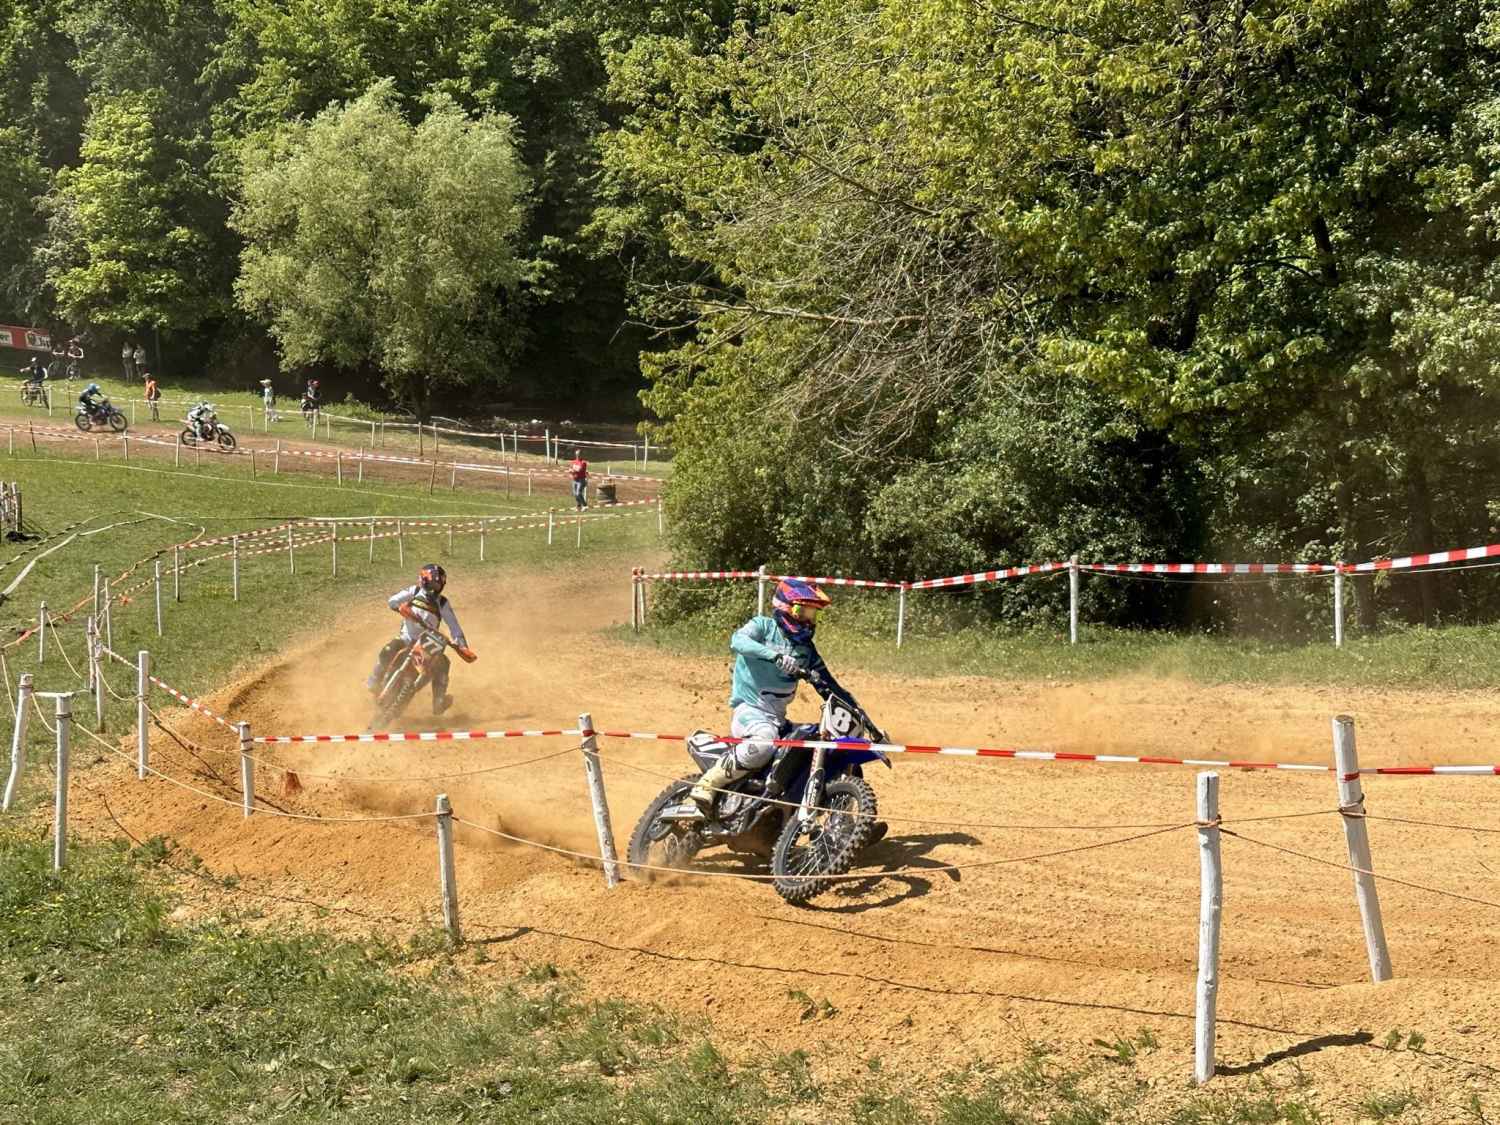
[629,675,891,903]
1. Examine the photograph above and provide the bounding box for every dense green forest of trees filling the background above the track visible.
[0,0,1500,629]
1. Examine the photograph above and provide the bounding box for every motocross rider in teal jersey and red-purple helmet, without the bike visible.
[689,578,885,839]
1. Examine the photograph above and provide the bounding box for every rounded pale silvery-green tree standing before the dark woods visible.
[234,83,527,419]
